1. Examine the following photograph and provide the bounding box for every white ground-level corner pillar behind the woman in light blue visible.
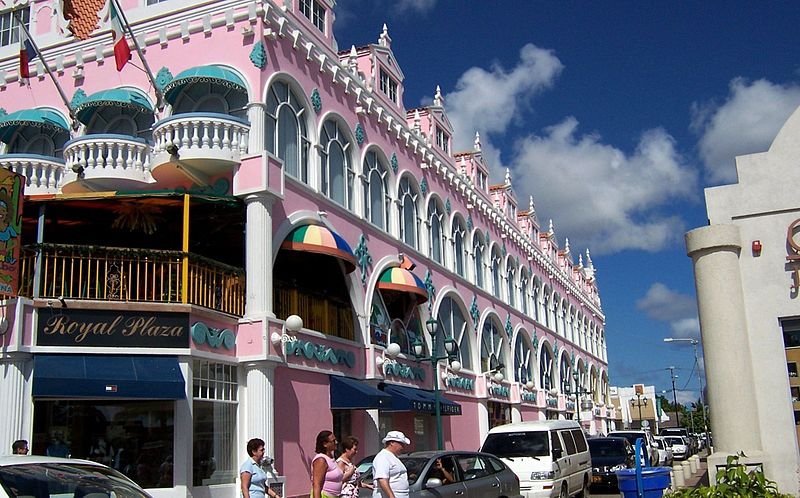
[242,362,281,460]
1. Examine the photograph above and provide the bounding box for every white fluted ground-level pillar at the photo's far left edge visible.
[0,355,33,454]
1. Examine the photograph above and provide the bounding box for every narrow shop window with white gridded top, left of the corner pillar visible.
[192,360,239,486]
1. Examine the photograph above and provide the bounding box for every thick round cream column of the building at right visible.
[686,225,762,454]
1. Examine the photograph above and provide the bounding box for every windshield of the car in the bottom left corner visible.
[0,462,150,498]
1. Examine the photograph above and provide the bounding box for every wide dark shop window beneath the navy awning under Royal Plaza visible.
[31,400,175,488]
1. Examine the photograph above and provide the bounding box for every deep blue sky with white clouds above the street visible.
[335,0,800,401]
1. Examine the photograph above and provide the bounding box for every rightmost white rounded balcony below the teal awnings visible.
[152,112,250,183]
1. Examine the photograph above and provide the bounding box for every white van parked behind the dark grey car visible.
[481,420,592,498]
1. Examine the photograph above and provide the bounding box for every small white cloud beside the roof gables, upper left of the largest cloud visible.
[445,44,564,154]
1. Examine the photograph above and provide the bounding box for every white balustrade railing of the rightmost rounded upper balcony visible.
[153,113,250,160]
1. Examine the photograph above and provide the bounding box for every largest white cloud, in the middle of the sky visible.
[511,117,699,254]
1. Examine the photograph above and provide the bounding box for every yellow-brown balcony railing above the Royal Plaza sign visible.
[20,244,245,316]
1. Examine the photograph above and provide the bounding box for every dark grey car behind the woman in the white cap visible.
[359,451,522,498]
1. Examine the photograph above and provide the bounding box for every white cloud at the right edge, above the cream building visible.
[691,78,800,185]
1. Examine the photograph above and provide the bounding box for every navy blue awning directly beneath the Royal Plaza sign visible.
[33,354,186,399]
